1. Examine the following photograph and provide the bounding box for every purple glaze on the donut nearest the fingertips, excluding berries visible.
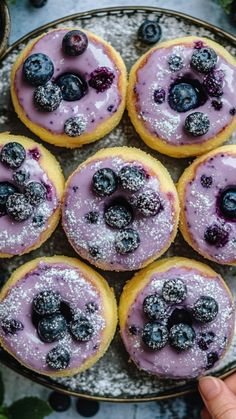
[121,266,234,379]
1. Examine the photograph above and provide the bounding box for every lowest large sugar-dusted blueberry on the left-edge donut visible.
[6,193,33,222]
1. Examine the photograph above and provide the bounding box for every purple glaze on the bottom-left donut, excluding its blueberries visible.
[0,262,105,372]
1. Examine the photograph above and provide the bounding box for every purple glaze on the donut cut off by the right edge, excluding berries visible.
[183,152,236,264]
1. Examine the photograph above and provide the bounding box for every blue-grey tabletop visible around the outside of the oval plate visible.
[0,0,236,419]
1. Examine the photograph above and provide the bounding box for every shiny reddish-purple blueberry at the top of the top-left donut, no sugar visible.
[62,30,88,57]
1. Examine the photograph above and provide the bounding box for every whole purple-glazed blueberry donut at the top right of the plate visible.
[127,36,236,158]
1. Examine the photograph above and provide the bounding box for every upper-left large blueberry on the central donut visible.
[92,168,118,196]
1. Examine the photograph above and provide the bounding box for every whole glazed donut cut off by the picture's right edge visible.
[178,145,236,265]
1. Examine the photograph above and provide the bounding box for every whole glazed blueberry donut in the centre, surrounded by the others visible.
[62,147,179,271]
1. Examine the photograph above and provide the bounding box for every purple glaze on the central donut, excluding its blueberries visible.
[62,156,176,271]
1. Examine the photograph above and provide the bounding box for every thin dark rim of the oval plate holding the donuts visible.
[0,5,236,403]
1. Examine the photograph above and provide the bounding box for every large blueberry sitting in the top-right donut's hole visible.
[168,83,198,112]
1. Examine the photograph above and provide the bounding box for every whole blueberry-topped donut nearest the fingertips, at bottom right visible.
[119,257,235,379]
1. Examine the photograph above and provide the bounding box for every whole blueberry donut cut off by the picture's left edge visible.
[0,133,64,258]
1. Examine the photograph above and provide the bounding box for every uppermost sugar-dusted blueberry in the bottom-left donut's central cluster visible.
[33,290,61,316]
